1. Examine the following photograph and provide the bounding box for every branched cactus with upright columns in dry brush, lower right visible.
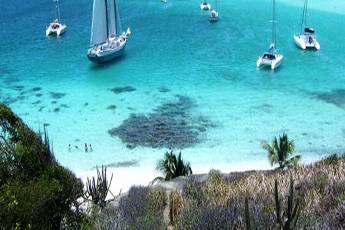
[274,177,301,230]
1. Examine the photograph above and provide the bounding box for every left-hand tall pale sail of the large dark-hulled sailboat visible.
[91,0,108,46]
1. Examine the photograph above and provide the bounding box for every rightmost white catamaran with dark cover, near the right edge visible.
[293,0,321,50]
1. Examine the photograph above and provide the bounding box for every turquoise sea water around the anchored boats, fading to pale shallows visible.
[0,0,345,171]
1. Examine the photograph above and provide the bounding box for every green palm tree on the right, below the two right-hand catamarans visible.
[262,133,301,169]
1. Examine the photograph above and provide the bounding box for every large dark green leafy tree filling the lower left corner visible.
[0,103,83,229]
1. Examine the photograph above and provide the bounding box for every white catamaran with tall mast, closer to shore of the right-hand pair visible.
[256,0,284,70]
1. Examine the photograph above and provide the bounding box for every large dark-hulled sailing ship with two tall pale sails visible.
[87,0,131,63]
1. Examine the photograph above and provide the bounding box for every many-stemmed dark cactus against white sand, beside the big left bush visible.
[86,165,113,209]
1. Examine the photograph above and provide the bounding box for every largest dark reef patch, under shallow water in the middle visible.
[109,95,214,149]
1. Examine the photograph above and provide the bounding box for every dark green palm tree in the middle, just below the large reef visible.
[154,150,193,181]
